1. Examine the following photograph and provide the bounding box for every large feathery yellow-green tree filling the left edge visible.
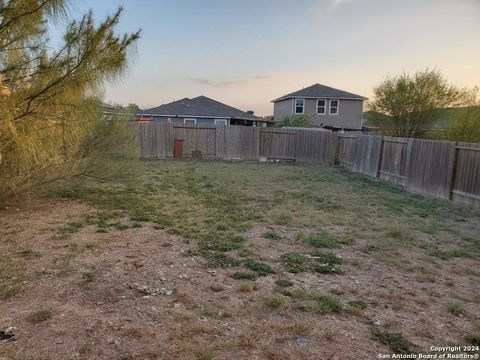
[0,0,140,194]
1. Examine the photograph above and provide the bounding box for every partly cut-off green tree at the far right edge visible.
[445,87,480,142]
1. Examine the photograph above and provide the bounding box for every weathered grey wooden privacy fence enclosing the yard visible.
[135,123,480,206]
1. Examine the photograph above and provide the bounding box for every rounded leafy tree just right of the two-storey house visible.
[369,69,464,138]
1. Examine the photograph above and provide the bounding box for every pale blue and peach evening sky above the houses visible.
[51,0,480,116]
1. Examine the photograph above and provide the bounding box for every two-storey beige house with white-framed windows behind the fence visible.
[272,84,367,130]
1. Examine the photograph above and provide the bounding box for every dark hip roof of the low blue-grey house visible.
[137,96,260,121]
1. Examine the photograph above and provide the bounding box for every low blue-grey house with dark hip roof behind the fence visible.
[136,96,265,126]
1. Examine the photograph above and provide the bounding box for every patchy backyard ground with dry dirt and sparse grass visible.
[0,161,480,360]
